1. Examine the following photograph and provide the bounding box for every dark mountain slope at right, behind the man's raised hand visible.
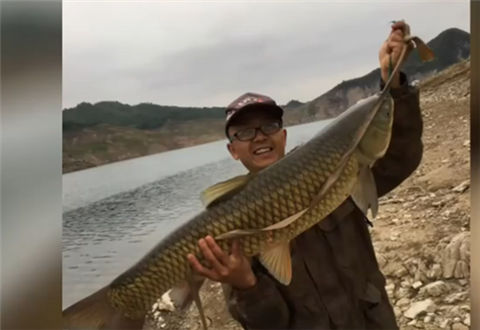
[297,28,470,120]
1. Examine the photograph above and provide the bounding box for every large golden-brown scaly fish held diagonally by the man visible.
[63,27,431,328]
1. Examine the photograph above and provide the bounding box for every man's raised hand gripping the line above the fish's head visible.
[378,21,412,88]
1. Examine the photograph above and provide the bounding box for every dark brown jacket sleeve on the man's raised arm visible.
[372,73,423,197]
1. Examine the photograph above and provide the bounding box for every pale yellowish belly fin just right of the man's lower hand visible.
[258,241,292,285]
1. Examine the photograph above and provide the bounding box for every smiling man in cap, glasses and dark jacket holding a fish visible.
[188,22,422,329]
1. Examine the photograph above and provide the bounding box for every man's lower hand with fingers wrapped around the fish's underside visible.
[187,236,257,289]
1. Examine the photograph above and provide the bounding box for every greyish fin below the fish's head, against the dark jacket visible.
[352,166,378,218]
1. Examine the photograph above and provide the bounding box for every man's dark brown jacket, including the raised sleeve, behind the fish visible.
[224,76,423,330]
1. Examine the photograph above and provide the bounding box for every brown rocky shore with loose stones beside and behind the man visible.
[146,61,470,330]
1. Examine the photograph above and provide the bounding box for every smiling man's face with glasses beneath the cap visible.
[227,109,287,172]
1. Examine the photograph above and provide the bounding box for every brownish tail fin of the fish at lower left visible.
[62,286,138,329]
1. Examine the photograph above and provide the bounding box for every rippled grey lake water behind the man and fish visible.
[62,120,329,308]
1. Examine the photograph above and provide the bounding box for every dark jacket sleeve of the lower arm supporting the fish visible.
[223,261,290,329]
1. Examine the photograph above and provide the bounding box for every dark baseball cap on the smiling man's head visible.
[225,93,283,137]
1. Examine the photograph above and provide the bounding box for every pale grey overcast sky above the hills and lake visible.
[63,0,470,108]
